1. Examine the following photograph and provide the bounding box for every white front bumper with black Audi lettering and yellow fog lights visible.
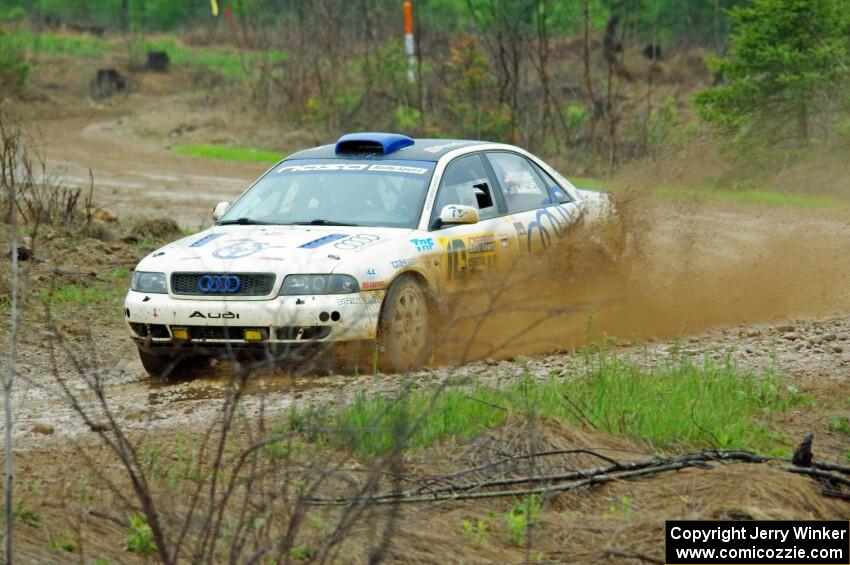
[124,290,385,352]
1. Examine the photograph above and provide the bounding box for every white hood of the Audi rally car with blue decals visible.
[136,226,413,273]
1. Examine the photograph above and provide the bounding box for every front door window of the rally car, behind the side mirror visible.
[431,154,499,225]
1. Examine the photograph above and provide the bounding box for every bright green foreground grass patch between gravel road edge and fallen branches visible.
[289,353,806,456]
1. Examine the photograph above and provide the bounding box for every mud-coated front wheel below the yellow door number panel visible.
[378,275,433,372]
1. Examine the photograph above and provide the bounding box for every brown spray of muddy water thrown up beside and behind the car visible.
[438,192,850,363]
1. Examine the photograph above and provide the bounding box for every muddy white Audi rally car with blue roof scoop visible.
[124,133,613,376]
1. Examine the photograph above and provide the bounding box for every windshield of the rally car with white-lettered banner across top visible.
[219,159,434,228]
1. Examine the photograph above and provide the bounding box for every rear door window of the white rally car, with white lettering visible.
[487,152,552,213]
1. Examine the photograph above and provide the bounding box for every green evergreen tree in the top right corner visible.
[695,0,850,143]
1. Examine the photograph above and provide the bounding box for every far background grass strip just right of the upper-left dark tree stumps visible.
[135,38,288,80]
